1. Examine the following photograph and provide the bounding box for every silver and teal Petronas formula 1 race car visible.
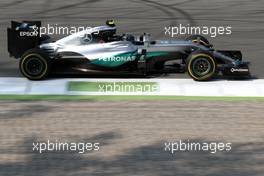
[8,20,250,81]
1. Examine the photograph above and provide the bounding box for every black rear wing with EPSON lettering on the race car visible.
[7,21,41,58]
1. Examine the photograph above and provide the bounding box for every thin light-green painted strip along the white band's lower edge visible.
[0,95,264,101]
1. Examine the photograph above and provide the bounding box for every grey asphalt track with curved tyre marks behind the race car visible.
[0,0,264,78]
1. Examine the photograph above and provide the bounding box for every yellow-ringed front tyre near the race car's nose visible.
[187,52,216,81]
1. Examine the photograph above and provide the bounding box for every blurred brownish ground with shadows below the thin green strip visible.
[0,100,264,176]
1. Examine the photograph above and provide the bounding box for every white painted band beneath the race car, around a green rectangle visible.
[0,77,264,97]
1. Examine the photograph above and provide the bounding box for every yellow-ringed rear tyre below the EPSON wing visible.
[19,49,51,80]
